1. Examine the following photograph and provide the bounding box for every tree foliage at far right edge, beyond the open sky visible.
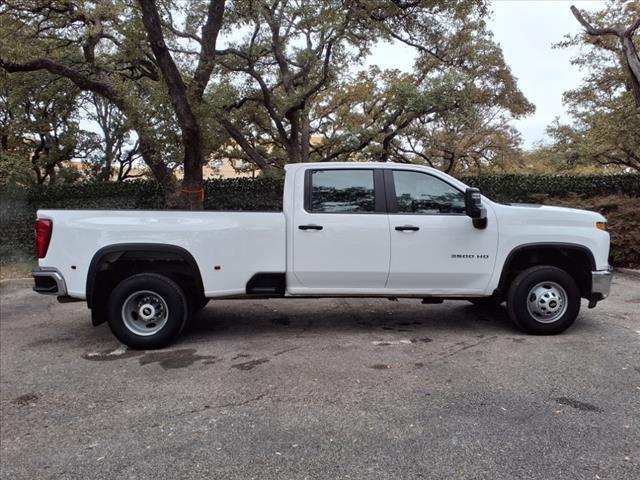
[547,0,640,171]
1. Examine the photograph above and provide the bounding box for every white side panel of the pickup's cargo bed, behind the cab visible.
[38,210,286,298]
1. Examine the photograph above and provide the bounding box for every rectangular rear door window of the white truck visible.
[310,170,375,213]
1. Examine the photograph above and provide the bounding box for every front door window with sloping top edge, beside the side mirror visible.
[393,170,465,214]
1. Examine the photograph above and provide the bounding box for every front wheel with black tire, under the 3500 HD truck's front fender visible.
[507,265,580,335]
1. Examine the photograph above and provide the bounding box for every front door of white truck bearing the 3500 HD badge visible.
[385,169,498,295]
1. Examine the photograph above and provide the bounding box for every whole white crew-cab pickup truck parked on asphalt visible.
[33,163,611,349]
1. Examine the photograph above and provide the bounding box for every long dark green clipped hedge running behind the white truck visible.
[0,174,640,262]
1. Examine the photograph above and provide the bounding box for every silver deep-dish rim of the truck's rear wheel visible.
[122,290,169,337]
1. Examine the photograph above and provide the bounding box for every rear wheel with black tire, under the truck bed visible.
[108,273,191,350]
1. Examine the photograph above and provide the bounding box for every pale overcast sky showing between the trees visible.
[367,0,606,148]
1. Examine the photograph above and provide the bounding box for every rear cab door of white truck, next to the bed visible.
[287,166,391,294]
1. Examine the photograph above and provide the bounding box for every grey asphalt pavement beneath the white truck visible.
[0,275,640,479]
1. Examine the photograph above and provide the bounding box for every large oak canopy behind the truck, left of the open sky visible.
[0,0,544,195]
